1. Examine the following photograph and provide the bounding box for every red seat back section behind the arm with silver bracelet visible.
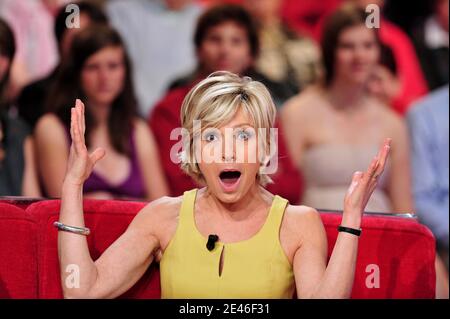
[27,200,160,299]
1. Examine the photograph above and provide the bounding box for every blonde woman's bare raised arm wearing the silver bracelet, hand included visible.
[58,100,159,298]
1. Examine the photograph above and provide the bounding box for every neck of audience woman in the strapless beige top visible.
[328,79,367,111]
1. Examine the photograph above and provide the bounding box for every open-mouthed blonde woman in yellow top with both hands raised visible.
[56,73,390,298]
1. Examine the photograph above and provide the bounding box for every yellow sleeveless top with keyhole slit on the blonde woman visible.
[160,189,295,299]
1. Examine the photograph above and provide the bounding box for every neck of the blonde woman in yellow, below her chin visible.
[205,183,266,221]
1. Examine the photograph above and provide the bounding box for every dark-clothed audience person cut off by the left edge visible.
[0,19,41,197]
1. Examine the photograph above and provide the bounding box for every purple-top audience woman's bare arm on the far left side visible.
[34,114,69,197]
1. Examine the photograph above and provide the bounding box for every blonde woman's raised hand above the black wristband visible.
[342,138,391,228]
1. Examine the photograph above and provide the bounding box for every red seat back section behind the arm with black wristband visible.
[321,212,436,299]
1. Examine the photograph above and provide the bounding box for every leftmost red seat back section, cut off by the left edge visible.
[0,203,38,299]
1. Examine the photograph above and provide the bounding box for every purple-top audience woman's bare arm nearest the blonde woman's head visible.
[136,120,169,200]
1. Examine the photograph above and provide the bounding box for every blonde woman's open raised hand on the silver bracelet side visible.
[64,99,105,185]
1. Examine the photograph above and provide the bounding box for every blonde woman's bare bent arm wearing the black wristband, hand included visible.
[294,140,390,298]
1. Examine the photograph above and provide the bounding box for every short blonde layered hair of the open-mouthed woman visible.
[180,71,276,186]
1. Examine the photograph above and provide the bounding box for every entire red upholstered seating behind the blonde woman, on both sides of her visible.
[0,200,435,298]
